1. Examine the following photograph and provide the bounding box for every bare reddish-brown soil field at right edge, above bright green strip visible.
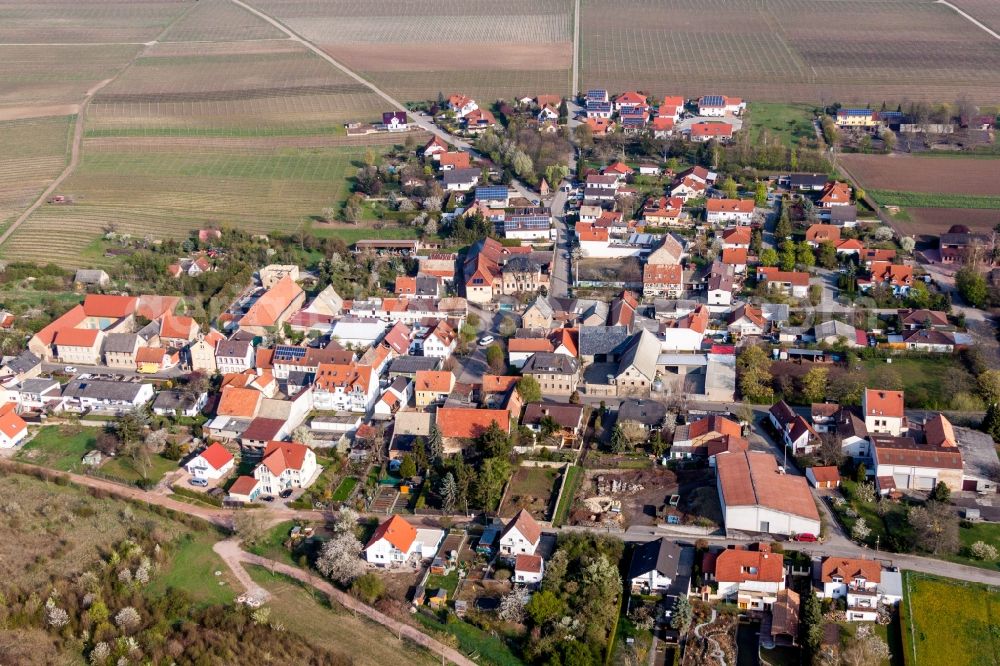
[837,154,1000,195]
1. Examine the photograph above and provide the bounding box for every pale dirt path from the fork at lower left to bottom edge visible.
[213,539,476,666]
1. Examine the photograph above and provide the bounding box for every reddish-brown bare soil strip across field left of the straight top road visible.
[323,42,573,72]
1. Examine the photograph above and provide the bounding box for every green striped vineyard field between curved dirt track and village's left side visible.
[3,139,386,266]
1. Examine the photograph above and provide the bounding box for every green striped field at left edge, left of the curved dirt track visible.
[0,116,72,225]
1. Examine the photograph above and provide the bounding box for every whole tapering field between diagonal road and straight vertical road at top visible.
[243,0,573,102]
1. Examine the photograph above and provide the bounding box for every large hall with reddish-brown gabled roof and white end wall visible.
[715,451,820,536]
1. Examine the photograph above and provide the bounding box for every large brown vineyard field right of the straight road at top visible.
[580,0,1000,103]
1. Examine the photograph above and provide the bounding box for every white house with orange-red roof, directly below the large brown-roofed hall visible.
[702,543,785,611]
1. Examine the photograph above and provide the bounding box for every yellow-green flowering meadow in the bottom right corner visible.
[902,571,1000,666]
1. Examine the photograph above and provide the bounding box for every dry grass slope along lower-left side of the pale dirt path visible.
[247,565,439,666]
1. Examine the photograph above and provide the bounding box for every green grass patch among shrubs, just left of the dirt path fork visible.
[147,531,238,604]
